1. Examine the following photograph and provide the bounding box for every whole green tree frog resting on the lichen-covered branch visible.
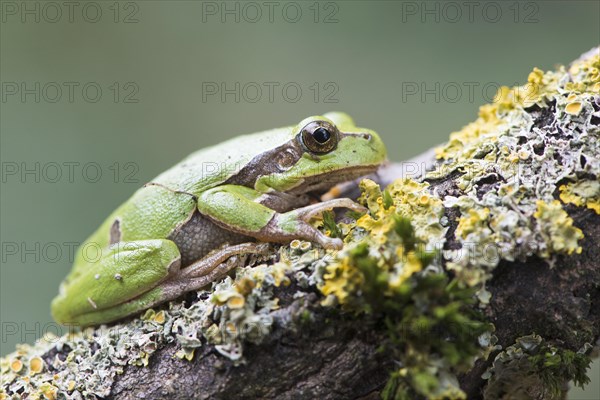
[51,112,386,327]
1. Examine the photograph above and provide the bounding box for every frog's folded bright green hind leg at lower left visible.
[51,239,181,326]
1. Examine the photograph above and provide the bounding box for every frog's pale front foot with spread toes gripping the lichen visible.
[265,199,367,250]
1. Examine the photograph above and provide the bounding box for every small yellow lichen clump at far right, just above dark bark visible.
[533,200,583,254]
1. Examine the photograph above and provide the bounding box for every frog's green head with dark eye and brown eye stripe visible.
[255,112,386,194]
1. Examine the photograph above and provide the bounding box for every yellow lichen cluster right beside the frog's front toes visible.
[319,179,446,305]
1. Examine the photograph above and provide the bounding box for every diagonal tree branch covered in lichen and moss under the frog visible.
[0,48,600,399]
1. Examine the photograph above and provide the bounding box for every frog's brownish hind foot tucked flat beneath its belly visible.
[166,243,269,297]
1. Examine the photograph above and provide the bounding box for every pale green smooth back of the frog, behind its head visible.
[72,128,293,260]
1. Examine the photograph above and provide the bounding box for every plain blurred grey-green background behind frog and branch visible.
[0,1,600,399]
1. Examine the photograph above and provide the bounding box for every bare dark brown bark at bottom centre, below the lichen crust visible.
[112,296,387,399]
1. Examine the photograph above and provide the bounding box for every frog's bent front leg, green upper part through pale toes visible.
[198,185,366,249]
